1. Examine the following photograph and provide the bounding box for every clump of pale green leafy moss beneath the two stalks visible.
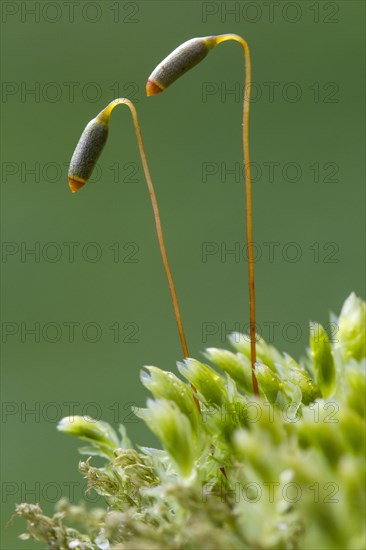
[16,294,366,550]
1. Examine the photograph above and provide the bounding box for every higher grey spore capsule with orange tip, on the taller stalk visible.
[146,36,216,96]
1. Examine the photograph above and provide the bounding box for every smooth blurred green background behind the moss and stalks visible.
[1,1,365,549]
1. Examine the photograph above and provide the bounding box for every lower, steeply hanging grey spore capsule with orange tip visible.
[68,115,108,193]
